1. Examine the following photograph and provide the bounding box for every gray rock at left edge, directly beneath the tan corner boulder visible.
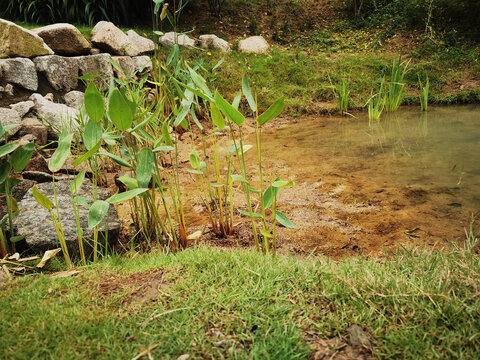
[0,58,38,91]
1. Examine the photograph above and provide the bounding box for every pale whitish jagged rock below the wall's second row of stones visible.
[30,94,78,134]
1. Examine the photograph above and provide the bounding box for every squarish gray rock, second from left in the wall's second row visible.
[33,55,78,91]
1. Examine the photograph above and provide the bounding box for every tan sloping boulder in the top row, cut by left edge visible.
[0,19,53,58]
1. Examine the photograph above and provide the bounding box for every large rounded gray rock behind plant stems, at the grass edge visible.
[13,180,120,256]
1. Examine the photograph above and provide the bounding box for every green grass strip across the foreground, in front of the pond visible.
[0,240,480,359]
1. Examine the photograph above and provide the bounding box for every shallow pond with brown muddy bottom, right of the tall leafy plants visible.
[240,106,480,257]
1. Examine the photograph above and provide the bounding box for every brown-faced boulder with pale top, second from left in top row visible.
[33,24,92,56]
